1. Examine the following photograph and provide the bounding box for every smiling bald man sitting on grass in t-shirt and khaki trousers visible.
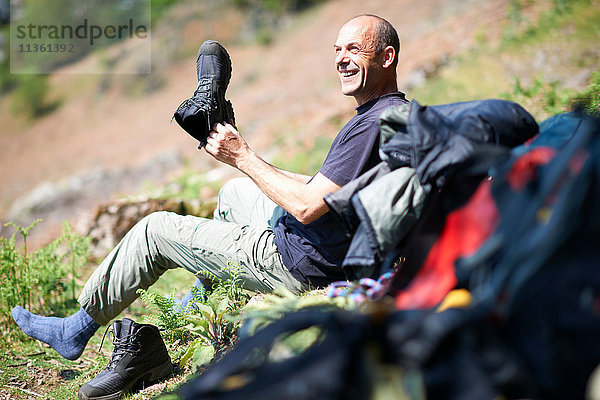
[13,15,406,359]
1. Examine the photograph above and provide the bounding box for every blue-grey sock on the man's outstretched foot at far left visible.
[12,306,100,360]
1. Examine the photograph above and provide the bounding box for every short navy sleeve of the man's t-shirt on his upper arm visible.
[319,120,379,186]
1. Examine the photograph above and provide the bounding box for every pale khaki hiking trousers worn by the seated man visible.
[78,178,306,325]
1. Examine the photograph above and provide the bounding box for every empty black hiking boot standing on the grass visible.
[78,318,173,400]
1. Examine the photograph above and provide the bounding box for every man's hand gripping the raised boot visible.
[204,123,252,168]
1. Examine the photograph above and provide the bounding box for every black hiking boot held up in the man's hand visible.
[173,40,234,148]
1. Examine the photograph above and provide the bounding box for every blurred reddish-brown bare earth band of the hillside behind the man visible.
[0,0,548,247]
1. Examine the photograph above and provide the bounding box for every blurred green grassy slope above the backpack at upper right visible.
[411,1,600,120]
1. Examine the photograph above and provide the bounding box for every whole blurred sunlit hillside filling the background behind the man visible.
[0,0,600,246]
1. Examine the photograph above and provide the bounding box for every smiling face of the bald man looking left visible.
[334,17,395,106]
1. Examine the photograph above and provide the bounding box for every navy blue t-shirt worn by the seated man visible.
[273,92,407,287]
